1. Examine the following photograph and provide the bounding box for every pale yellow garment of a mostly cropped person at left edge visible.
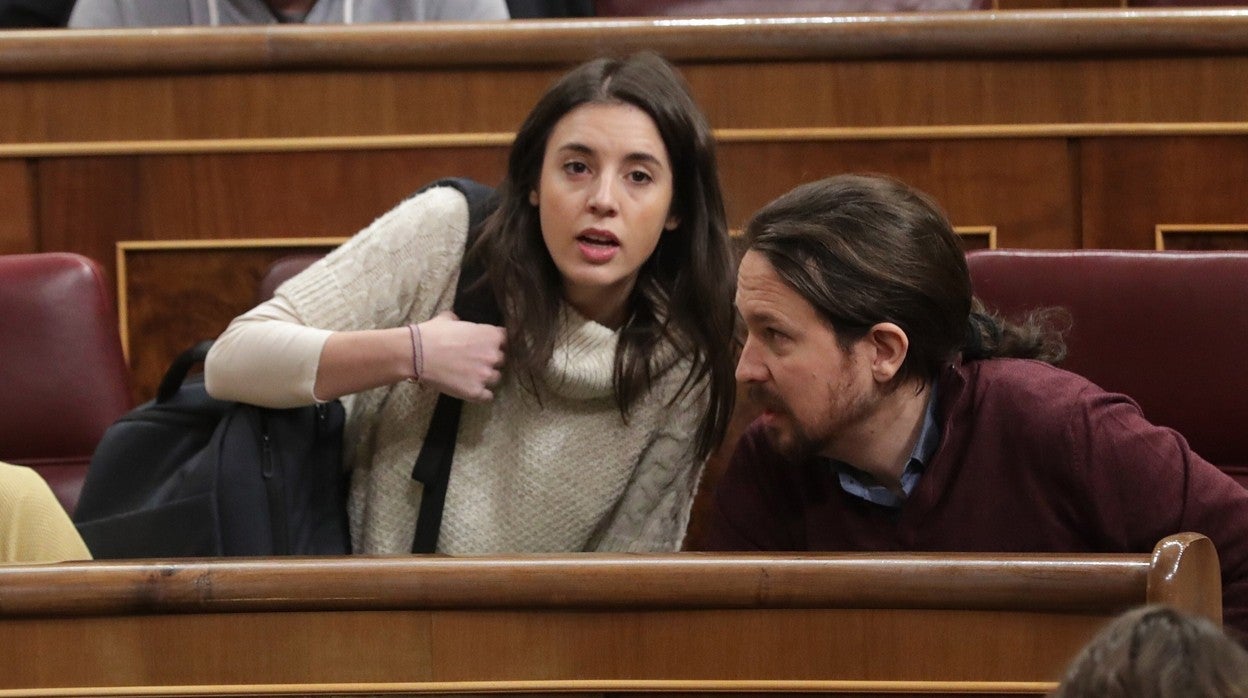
[0,463,91,563]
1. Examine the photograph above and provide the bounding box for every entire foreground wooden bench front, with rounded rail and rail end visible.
[0,533,1222,697]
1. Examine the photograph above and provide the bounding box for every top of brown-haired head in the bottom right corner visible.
[1053,606,1248,698]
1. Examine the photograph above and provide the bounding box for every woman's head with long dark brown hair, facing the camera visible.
[479,52,735,455]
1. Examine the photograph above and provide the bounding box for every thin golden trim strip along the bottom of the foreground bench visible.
[0,679,1057,698]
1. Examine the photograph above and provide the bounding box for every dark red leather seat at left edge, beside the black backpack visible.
[0,252,134,513]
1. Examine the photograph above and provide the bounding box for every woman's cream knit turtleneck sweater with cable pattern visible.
[207,189,705,554]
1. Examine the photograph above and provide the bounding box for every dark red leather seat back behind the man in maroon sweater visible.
[967,250,1248,484]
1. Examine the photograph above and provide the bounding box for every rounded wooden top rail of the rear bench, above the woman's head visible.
[7,9,1248,74]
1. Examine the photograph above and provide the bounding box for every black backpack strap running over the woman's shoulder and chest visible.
[412,177,503,553]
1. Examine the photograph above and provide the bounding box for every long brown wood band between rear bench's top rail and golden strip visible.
[7,55,1248,144]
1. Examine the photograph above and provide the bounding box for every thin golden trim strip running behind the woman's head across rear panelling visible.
[7,121,1248,159]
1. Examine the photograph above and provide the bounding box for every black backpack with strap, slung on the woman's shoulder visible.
[74,179,500,558]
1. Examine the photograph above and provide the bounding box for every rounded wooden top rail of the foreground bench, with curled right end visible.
[0,554,1158,619]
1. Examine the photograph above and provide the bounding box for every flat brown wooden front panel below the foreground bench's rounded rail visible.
[0,608,1083,696]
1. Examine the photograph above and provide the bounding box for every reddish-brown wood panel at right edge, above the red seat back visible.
[1082,136,1248,250]
